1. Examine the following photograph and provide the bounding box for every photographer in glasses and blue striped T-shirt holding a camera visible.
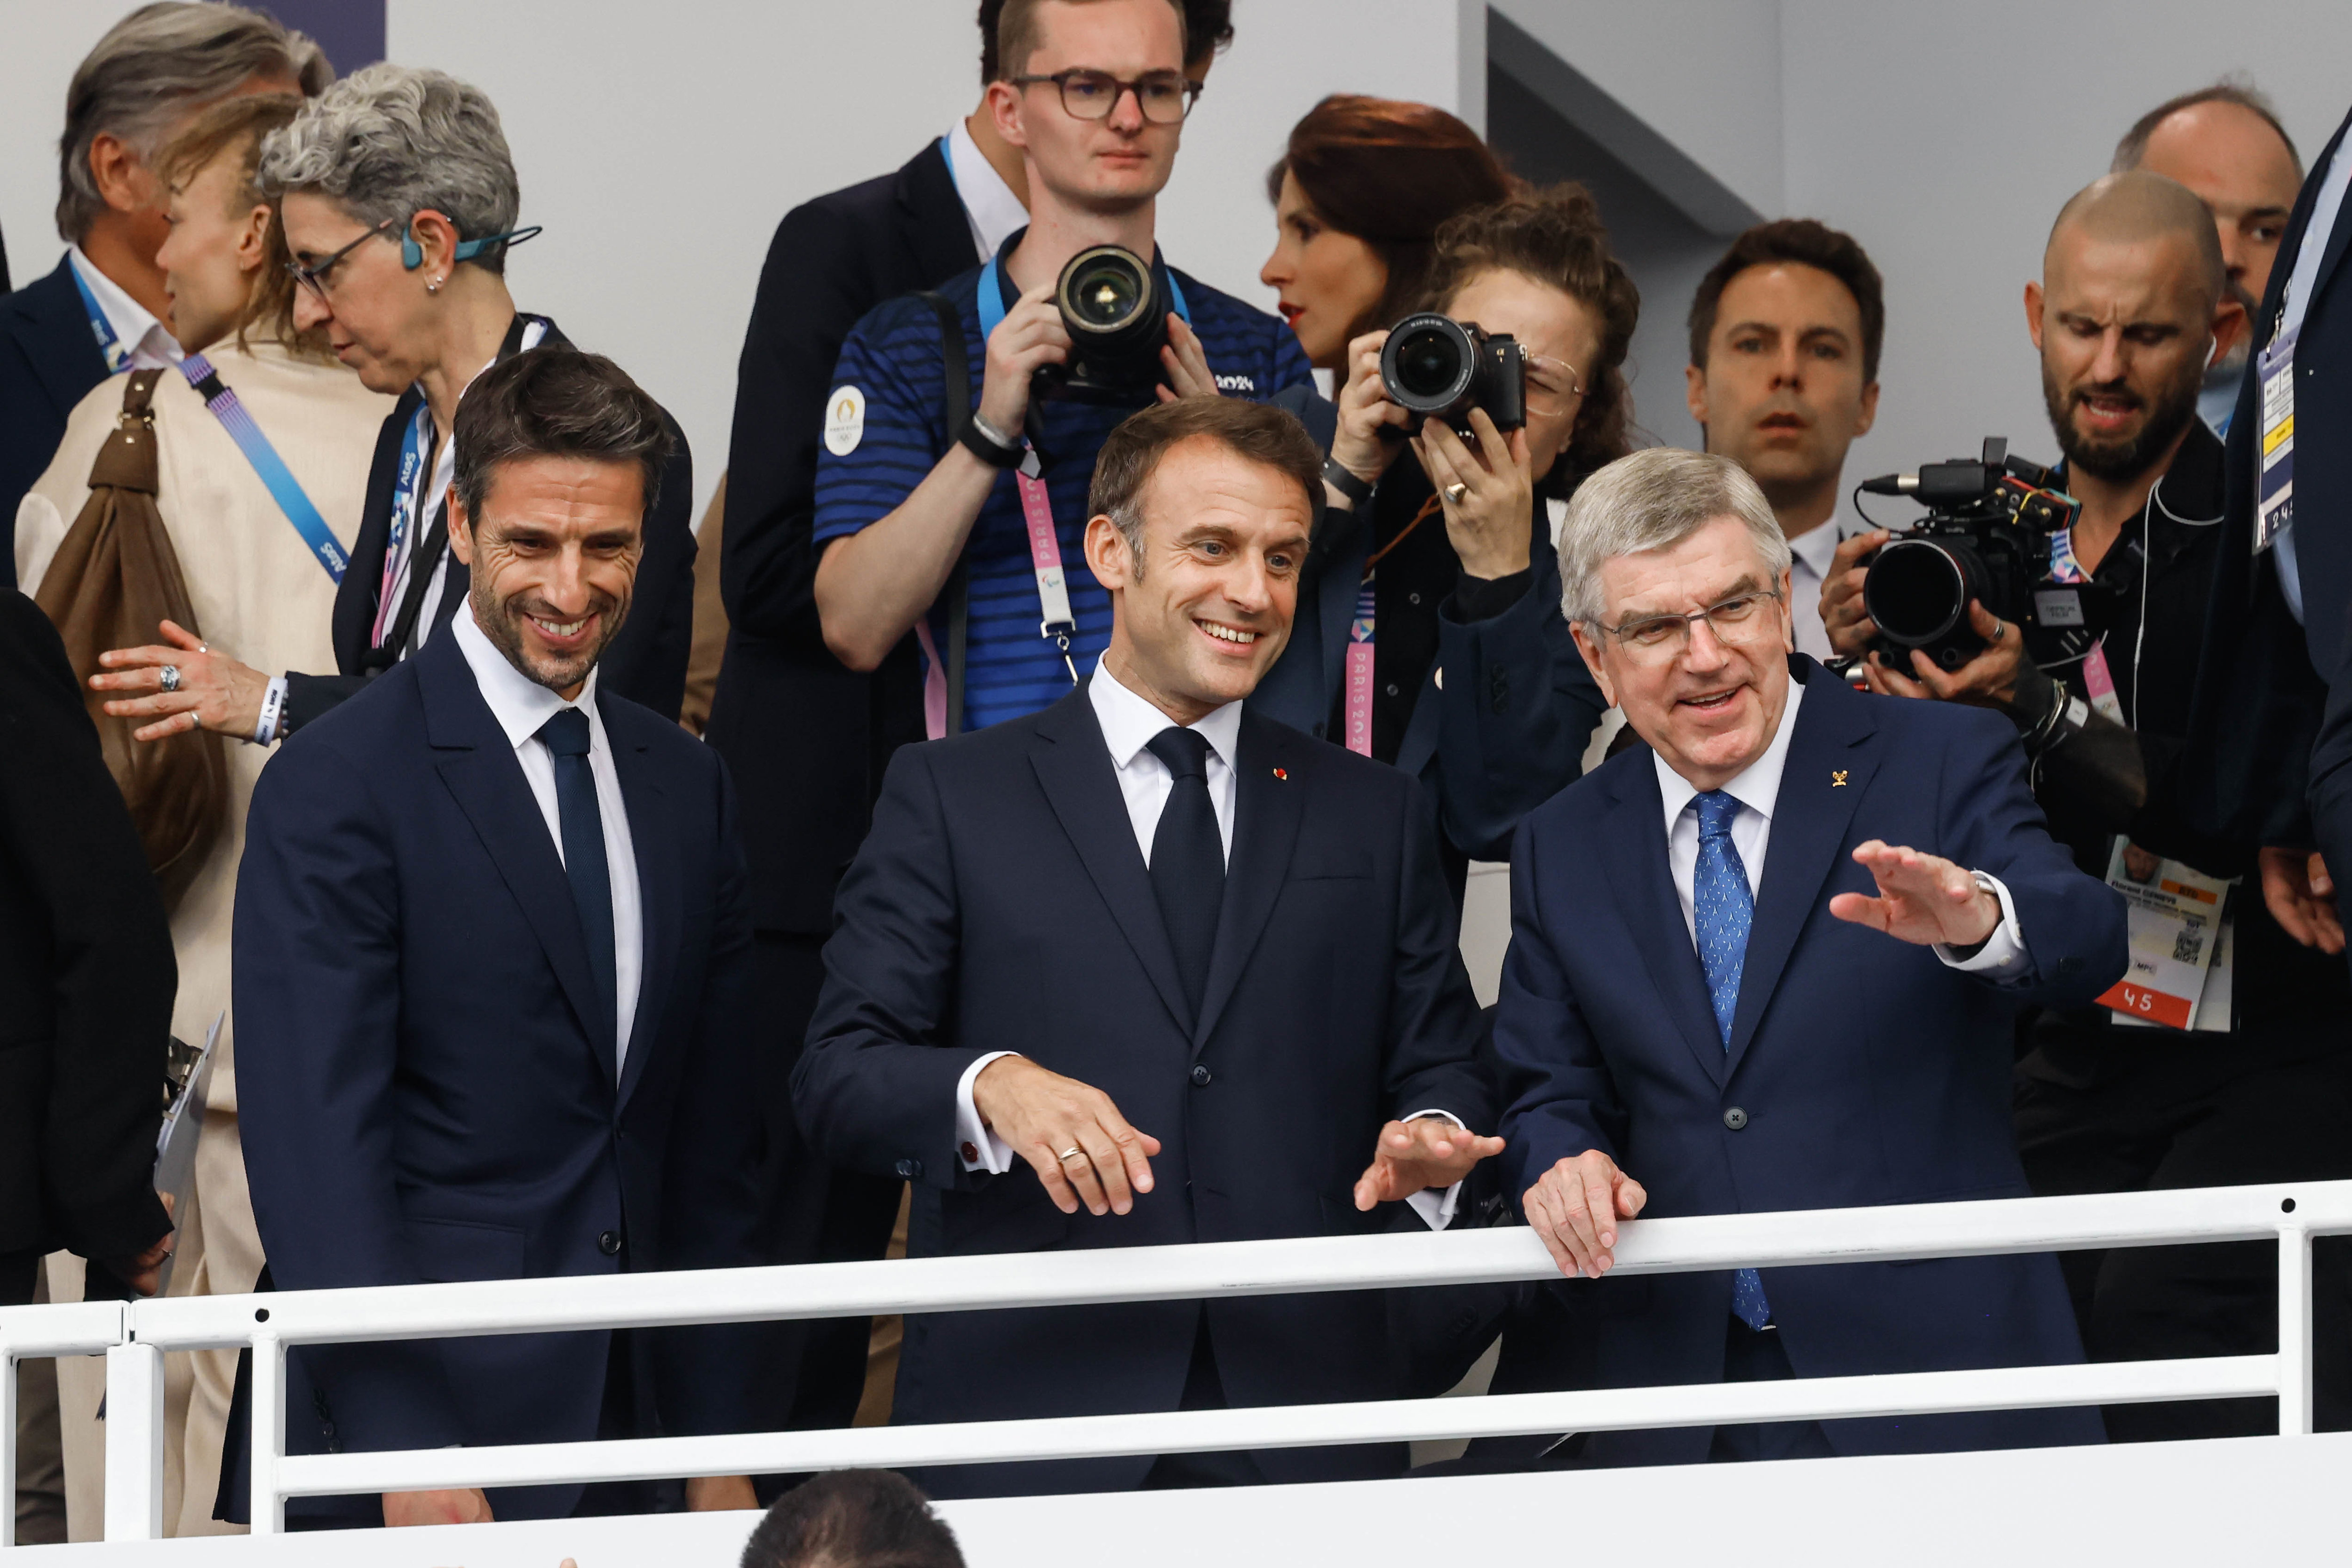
[814,0,1310,736]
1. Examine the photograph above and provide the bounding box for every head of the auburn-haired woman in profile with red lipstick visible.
[1258,94,1512,381]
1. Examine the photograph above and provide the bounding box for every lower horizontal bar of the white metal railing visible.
[278,1356,2279,1497]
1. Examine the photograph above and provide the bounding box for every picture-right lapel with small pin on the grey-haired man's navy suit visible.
[1731,658,1879,1070]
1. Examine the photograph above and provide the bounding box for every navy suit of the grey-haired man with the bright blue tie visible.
[1494,656,2124,1465]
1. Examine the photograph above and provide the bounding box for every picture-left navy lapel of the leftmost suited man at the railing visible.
[414,637,614,1077]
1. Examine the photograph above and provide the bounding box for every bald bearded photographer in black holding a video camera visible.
[1860,172,2352,1439]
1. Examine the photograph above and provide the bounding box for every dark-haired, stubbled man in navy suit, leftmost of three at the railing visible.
[235,348,757,1523]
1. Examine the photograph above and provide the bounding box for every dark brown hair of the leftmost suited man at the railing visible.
[452,348,677,526]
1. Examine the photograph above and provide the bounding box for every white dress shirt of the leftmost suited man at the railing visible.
[449,604,644,1072]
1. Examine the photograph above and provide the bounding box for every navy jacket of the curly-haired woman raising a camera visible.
[1249,388,1609,879]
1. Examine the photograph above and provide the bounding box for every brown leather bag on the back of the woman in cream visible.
[33,369,228,907]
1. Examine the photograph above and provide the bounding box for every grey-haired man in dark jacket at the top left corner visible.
[0,0,334,581]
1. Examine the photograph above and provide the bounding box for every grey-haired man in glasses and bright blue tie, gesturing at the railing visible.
[1496,449,2124,1465]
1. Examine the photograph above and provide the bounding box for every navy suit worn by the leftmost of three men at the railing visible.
[235,637,757,1519]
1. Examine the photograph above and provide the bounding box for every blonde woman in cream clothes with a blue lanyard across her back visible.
[16,94,390,1533]
